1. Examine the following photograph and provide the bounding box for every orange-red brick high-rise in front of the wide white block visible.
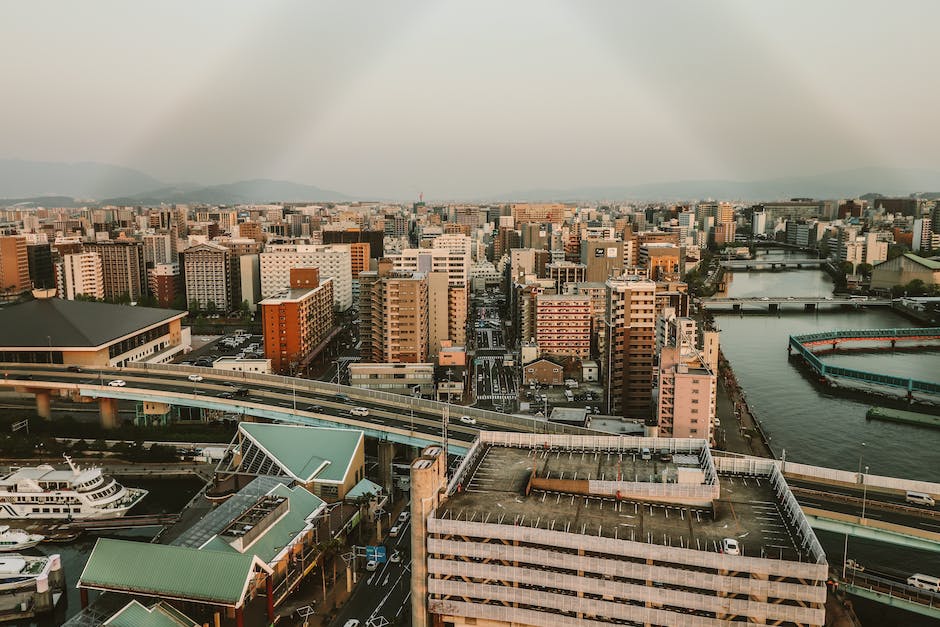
[258,268,334,374]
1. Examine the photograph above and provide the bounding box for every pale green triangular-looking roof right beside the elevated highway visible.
[238,422,363,483]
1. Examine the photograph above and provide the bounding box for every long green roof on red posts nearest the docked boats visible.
[78,538,270,607]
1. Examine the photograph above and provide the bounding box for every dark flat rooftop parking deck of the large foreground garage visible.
[437,445,811,561]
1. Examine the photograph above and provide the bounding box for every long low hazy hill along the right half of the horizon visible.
[486,168,940,201]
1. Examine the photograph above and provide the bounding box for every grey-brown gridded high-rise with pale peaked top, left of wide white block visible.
[180,242,233,312]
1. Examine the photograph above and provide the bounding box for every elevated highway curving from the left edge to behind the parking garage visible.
[0,364,592,453]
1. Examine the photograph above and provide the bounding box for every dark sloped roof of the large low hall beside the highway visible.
[0,298,185,349]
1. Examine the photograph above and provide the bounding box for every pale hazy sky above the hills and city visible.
[0,0,940,198]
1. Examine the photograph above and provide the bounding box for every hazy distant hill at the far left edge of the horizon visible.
[0,159,166,199]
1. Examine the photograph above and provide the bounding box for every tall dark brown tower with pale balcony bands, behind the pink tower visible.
[602,277,656,418]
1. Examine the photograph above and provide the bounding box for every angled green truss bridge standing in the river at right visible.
[787,327,940,398]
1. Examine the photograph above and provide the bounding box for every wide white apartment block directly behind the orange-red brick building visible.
[259,244,353,311]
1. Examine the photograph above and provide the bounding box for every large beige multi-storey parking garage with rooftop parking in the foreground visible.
[411,431,829,627]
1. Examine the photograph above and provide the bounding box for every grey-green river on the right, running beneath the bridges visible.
[715,253,940,627]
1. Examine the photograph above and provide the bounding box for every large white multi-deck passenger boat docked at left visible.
[0,456,147,520]
